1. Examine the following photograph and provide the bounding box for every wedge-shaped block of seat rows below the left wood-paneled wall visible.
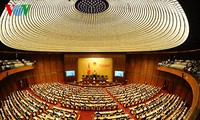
[29,83,81,104]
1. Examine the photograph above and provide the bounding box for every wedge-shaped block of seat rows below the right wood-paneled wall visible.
[106,84,161,107]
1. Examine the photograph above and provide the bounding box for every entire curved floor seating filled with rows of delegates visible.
[0,83,189,120]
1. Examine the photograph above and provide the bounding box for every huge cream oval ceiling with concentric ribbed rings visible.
[0,0,189,52]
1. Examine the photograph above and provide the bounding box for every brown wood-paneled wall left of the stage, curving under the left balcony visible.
[0,53,64,100]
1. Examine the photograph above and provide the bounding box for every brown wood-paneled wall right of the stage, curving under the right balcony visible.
[126,54,193,105]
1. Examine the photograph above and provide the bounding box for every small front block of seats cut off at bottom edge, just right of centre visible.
[94,109,130,120]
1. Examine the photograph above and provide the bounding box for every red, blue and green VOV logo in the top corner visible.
[5,0,31,16]
